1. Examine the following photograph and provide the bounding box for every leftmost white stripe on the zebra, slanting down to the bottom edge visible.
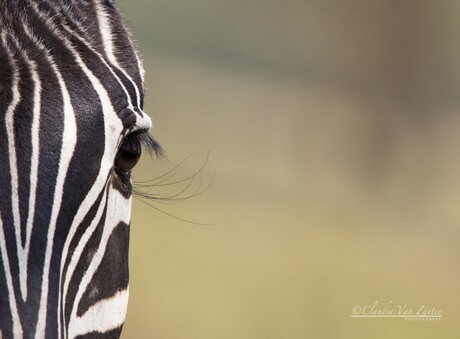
[0,214,23,338]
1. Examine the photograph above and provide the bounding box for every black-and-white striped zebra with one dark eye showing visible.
[0,0,161,338]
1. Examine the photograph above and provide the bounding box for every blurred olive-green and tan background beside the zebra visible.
[118,0,460,339]
